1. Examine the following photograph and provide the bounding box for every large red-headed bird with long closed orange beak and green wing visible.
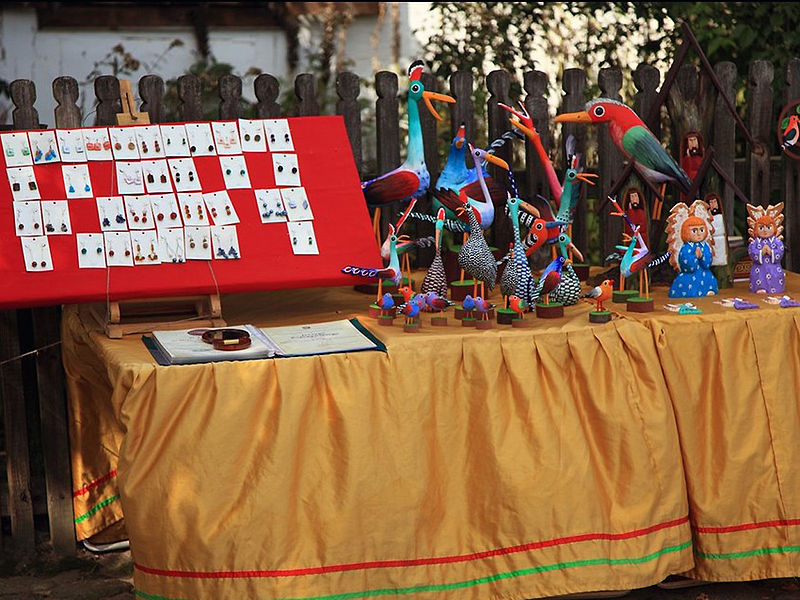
[555,98,692,192]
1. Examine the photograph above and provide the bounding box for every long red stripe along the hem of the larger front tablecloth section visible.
[135,516,689,579]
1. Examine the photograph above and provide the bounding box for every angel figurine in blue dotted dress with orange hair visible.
[667,200,718,298]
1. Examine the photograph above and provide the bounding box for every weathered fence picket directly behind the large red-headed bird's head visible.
[597,69,624,260]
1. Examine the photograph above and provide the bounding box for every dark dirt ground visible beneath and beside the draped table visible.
[0,551,800,600]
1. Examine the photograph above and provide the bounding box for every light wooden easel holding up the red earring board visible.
[97,79,227,339]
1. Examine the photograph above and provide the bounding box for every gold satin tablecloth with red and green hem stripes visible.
[63,277,800,599]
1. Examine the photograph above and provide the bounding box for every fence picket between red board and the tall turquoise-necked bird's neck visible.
[375,71,400,239]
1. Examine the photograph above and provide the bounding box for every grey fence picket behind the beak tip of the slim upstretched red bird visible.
[486,69,514,251]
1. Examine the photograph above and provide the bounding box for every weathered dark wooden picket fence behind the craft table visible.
[0,59,800,554]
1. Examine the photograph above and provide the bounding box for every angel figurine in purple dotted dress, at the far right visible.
[747,202,786,294]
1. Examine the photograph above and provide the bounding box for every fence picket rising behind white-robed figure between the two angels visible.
[712,62,736,235]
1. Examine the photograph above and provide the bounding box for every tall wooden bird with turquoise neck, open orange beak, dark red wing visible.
[361,60,455,243]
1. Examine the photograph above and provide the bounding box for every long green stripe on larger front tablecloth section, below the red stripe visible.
[284,540,692,600]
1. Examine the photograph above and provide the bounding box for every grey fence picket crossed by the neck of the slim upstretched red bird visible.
[522,71,552,198]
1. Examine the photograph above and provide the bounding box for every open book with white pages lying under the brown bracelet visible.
[142,319,386,365]
